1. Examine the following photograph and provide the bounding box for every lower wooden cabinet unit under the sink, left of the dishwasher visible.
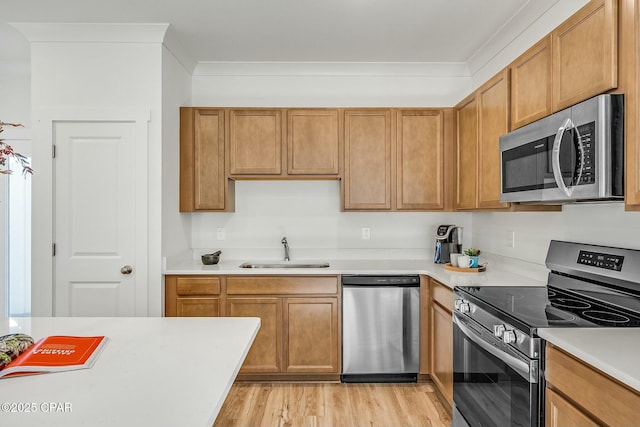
[165,275,341,381]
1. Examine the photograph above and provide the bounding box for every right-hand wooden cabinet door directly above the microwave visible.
[551,0,618,111]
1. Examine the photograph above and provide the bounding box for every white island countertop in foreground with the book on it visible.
[0,317,260,427]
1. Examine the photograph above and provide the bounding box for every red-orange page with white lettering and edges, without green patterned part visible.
[0,336,109,378]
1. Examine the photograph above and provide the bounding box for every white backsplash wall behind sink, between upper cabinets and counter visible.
[191,181,471,260]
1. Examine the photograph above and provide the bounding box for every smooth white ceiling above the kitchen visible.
[0,0,540,62]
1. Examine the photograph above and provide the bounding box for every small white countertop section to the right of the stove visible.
[538,328,640,392]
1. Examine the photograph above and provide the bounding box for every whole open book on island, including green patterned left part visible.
[0,334,109,378]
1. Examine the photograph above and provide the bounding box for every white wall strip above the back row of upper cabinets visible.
[193,63,471,107]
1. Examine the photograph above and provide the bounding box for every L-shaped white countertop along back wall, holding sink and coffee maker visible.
[164,260,546,288]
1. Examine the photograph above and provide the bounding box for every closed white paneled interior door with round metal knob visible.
[53,121,140,316]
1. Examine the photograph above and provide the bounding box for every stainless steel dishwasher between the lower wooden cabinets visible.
[341,276,420,382]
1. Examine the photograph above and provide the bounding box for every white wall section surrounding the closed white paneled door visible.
[27,35,162,315]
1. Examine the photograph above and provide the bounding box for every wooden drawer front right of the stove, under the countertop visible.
[545,345,640,426]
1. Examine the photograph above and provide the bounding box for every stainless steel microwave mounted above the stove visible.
[500,95,624,204]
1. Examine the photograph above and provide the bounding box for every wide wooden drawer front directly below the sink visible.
[227,276,338,295]
